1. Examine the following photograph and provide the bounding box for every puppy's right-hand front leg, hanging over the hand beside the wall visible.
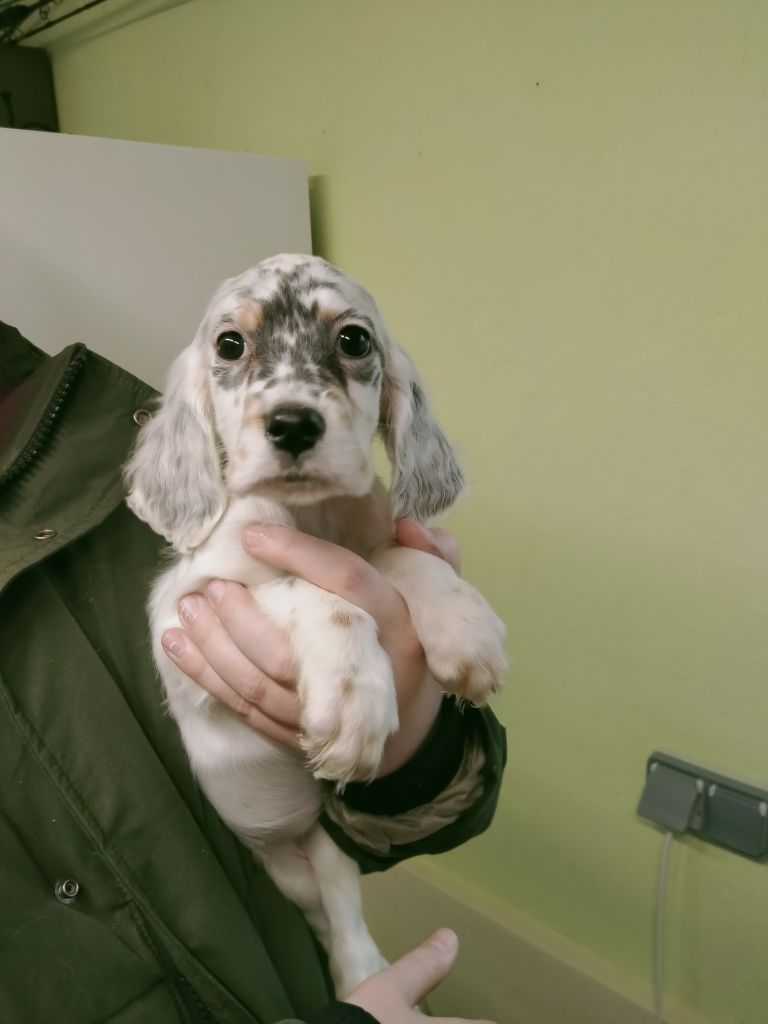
[372,547,507,705]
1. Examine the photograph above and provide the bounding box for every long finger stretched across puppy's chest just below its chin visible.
[243,523,399,622]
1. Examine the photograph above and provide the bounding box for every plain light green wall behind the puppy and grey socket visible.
[54,0,768,1024]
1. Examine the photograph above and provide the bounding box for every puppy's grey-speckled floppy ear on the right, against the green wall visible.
[381,343,465,519]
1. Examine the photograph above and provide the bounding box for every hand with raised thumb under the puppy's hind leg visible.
[344,928,499,1024]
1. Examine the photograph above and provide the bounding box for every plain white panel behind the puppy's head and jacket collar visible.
[0,129,311,387]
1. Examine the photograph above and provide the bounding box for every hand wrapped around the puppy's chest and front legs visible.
[163,519,459,774]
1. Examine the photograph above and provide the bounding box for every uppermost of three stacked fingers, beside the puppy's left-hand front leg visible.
[205,580,296,686]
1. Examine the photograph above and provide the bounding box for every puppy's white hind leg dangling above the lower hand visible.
[301,825,387,999]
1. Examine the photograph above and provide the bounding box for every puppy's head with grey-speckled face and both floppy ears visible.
[126,255,463,551]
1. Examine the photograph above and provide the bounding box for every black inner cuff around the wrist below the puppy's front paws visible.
[341,698,468,815]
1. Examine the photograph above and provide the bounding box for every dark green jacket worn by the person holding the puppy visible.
[0,325,505,1024]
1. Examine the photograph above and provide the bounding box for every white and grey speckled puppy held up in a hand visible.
[126,255,505,996]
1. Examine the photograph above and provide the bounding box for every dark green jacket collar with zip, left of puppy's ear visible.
[0,325,156,589]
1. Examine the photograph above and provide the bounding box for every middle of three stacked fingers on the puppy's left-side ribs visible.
[179,594,299,728]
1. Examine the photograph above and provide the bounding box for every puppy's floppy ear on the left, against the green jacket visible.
[125,345,225,553]
